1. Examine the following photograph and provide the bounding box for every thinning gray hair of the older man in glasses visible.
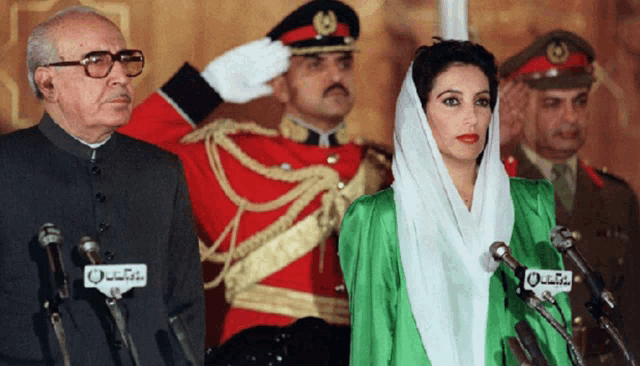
[27,5,115,99]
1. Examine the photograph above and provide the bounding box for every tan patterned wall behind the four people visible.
[0,0,640,194]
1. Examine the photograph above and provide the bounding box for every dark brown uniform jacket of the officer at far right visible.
[508,148,640,365]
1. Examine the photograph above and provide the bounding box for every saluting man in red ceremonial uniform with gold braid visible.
[121,0,388,364]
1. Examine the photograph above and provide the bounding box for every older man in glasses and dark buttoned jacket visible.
[0,7,204,365]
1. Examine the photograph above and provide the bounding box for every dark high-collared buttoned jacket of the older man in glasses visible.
[0,115,204,366]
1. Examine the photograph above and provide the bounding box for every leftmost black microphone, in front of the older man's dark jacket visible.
[38,223,69,299]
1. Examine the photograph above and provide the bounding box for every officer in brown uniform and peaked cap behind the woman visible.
[500,30,640,365]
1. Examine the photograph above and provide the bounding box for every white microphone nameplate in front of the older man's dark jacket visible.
[84,264,147,298]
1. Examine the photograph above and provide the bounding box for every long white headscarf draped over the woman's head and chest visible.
[392,64,514,366]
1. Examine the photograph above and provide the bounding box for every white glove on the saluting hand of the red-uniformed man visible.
[201,37,291,103]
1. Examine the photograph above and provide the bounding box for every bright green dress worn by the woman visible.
[339,178,571,366]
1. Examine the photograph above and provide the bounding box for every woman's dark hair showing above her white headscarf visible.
[411,37,498,112]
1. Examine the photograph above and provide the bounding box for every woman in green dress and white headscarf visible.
[339,41,570,366]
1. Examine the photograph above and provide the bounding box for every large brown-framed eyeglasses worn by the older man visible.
[43,50,144,79]
